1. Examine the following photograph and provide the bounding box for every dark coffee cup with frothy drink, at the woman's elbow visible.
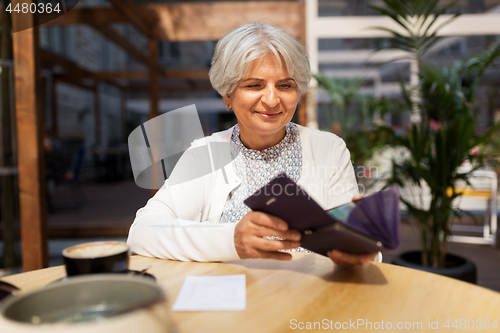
[62,241,129,276]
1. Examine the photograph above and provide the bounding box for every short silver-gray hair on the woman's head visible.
[208,22,311,97]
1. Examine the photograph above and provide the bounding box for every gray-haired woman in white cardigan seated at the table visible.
[127,23,375,266]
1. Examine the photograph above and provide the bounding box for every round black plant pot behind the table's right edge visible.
[392,251,477,284]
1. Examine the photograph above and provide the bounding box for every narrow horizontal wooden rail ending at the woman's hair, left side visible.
[93,68,209,81]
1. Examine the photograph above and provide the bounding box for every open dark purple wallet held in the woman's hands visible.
[245,173,401,256]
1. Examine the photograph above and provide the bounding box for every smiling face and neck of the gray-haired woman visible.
[225,53,299,150]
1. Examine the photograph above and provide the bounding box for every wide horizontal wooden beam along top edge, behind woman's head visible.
[41,0,305,41]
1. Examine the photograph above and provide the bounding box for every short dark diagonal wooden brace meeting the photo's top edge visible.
[109,0,156,38]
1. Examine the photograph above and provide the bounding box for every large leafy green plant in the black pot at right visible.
[372,0,500,282]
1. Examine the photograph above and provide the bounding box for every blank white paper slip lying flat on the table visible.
[172,274,247,311]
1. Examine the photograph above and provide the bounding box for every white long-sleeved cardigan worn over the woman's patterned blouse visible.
[127,125,358,261]
